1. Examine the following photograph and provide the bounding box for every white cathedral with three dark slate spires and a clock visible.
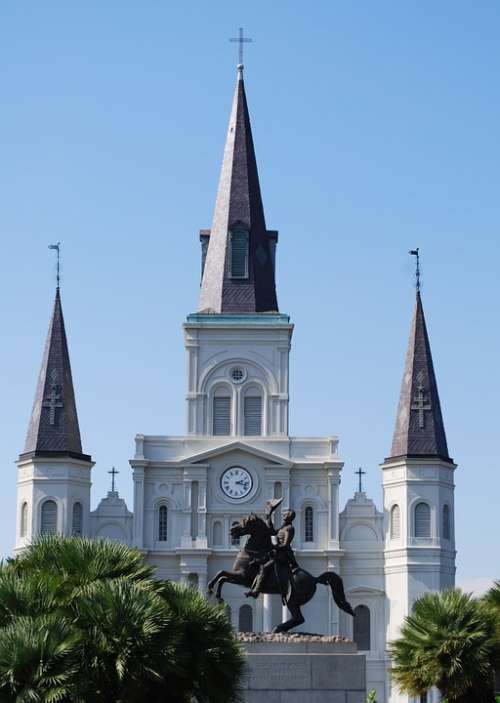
[15,65,456,703]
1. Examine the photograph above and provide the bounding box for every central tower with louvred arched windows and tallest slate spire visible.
[184,66,293,438]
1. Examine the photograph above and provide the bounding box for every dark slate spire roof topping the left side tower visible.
[24,287,90,461]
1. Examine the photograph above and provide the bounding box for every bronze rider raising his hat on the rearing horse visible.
[245,498,299,598]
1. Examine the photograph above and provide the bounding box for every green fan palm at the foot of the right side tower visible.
[389,590,495,703]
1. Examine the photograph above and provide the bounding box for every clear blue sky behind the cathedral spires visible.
[0,0,500,586]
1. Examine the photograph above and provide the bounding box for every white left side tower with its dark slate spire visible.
[15,287,93,551]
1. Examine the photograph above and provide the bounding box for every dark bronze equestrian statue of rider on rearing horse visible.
[208,498,354,632]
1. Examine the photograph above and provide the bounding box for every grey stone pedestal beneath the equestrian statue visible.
[240,633,366,703]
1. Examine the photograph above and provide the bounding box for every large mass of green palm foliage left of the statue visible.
[0,536,244,703]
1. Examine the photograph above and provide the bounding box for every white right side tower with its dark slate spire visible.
[382,289,456,703]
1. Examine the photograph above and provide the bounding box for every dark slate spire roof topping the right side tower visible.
[391,290,452,461]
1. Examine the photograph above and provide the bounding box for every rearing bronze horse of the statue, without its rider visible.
[208,513,354,632]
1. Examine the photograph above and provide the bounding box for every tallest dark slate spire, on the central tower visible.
[198,66,278,313]
